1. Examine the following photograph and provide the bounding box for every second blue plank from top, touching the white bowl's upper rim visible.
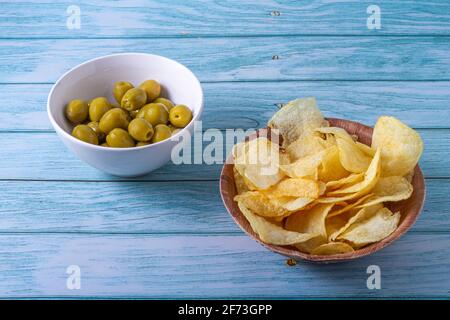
[0,36,450,83]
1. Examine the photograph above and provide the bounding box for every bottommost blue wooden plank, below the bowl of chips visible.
[0,234,450,299]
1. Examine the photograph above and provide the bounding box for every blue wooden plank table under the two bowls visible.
[0,0,450,299]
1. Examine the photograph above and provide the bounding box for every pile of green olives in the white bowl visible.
[65,80,192,148]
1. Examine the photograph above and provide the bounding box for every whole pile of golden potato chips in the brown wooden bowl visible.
[233,98,423,255]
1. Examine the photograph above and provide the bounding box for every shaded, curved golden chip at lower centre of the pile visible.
[284,204,333,239]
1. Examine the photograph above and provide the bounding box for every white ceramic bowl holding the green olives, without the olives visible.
[47,53,203,177]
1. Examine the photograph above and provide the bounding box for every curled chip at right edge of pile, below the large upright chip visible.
[357,176,413,208]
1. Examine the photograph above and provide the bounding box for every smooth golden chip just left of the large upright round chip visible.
[336,137,372,173]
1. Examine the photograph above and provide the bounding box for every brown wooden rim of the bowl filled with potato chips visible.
[220,118,426,263]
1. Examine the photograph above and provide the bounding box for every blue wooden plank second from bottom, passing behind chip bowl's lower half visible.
[0,180,450,233]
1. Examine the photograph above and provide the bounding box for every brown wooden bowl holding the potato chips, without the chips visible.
[220,118,425,263]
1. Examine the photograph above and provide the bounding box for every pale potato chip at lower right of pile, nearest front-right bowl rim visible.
[337,207,400,248]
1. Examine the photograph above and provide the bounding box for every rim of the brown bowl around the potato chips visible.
[219,118,426,263]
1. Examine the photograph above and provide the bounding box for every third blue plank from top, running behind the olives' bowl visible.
[4,81,450,131]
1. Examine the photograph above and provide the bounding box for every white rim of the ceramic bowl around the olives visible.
[47,52,205,152]
